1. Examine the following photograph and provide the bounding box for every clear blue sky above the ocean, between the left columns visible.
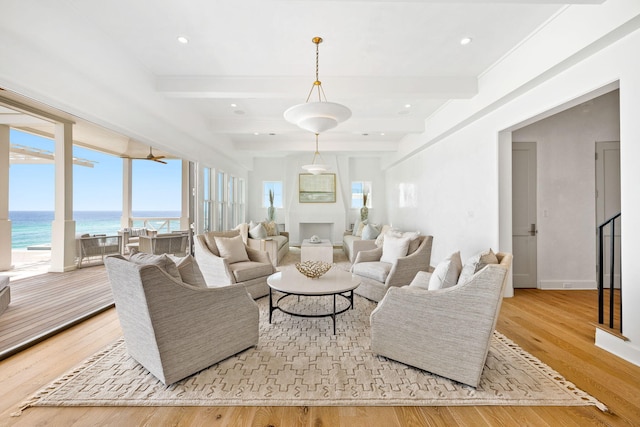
[9,129,182,211]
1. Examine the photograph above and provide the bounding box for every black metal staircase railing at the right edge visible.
[598,213,622,333]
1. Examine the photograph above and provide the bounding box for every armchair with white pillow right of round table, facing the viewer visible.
[351,236,433,301]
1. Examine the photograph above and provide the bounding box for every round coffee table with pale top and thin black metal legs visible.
[267,266,360,335]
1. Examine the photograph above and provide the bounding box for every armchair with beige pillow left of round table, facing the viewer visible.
[194,230,276,299]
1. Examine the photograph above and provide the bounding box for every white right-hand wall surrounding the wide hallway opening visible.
[386,10,640,365]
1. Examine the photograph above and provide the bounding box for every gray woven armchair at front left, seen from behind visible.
[105,255,259,384]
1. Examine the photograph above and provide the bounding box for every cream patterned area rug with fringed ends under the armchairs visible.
[16,290,606,415]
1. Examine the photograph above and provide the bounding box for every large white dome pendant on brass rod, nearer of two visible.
[284,37,351,133]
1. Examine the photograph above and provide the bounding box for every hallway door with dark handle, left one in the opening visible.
[512,142,538,288]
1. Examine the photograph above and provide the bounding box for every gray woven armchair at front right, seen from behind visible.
[371,253,512,387]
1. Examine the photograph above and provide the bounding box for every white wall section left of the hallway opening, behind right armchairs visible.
[386,123,498,265]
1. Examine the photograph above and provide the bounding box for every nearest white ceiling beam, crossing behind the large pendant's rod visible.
[156,76,478,99]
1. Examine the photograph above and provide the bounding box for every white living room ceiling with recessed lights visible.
[0,0,602,164]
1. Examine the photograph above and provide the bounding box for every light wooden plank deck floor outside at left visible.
[0,265,113,360]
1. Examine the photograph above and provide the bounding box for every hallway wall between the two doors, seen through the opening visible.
[513,90,620,289]
